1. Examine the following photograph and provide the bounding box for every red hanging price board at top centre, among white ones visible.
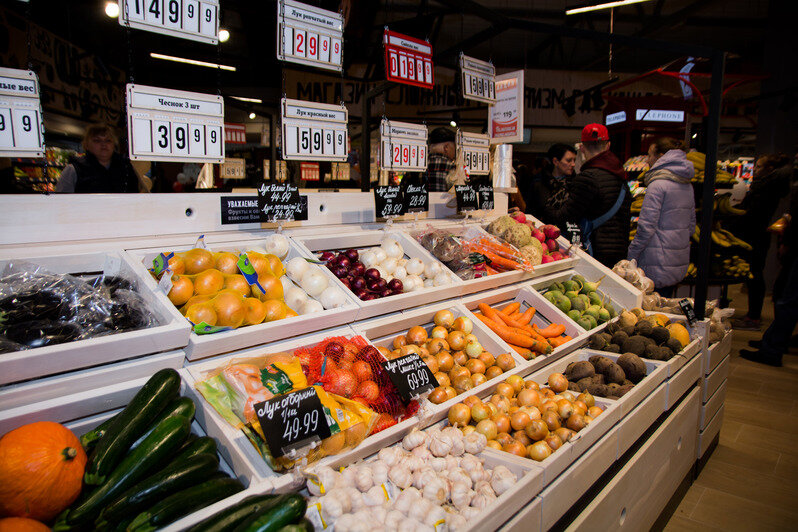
[382,30,435,89]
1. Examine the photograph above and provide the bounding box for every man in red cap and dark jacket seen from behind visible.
[546,124,632,267]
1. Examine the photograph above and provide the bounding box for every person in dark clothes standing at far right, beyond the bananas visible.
[732,153,792,331]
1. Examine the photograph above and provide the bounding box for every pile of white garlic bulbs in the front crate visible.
[308,427,517,532]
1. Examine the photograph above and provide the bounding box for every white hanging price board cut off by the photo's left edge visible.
[0,68,44,158]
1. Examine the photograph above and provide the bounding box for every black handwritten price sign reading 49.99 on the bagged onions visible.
[255,387,331,457]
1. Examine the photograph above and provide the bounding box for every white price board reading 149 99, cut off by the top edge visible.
[119,0,219,44]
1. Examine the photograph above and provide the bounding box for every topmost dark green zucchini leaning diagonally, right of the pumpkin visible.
[83,368,180,485]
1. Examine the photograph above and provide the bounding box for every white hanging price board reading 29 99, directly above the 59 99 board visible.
[277,0,344,72]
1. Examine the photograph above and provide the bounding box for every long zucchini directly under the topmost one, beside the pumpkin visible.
[56,416,191,529]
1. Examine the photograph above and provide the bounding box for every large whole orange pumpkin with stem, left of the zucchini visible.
[0,421,86,521]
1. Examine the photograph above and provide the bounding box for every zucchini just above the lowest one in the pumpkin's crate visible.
[100,454,219,521]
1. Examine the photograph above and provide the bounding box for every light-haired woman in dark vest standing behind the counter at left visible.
[55,124,141,194]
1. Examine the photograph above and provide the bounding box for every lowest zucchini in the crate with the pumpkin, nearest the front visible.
[127,478,244,532]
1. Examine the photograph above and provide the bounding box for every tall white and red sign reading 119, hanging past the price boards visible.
[488,70,524,144]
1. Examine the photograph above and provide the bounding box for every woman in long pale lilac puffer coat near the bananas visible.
[627,138,695,297]
